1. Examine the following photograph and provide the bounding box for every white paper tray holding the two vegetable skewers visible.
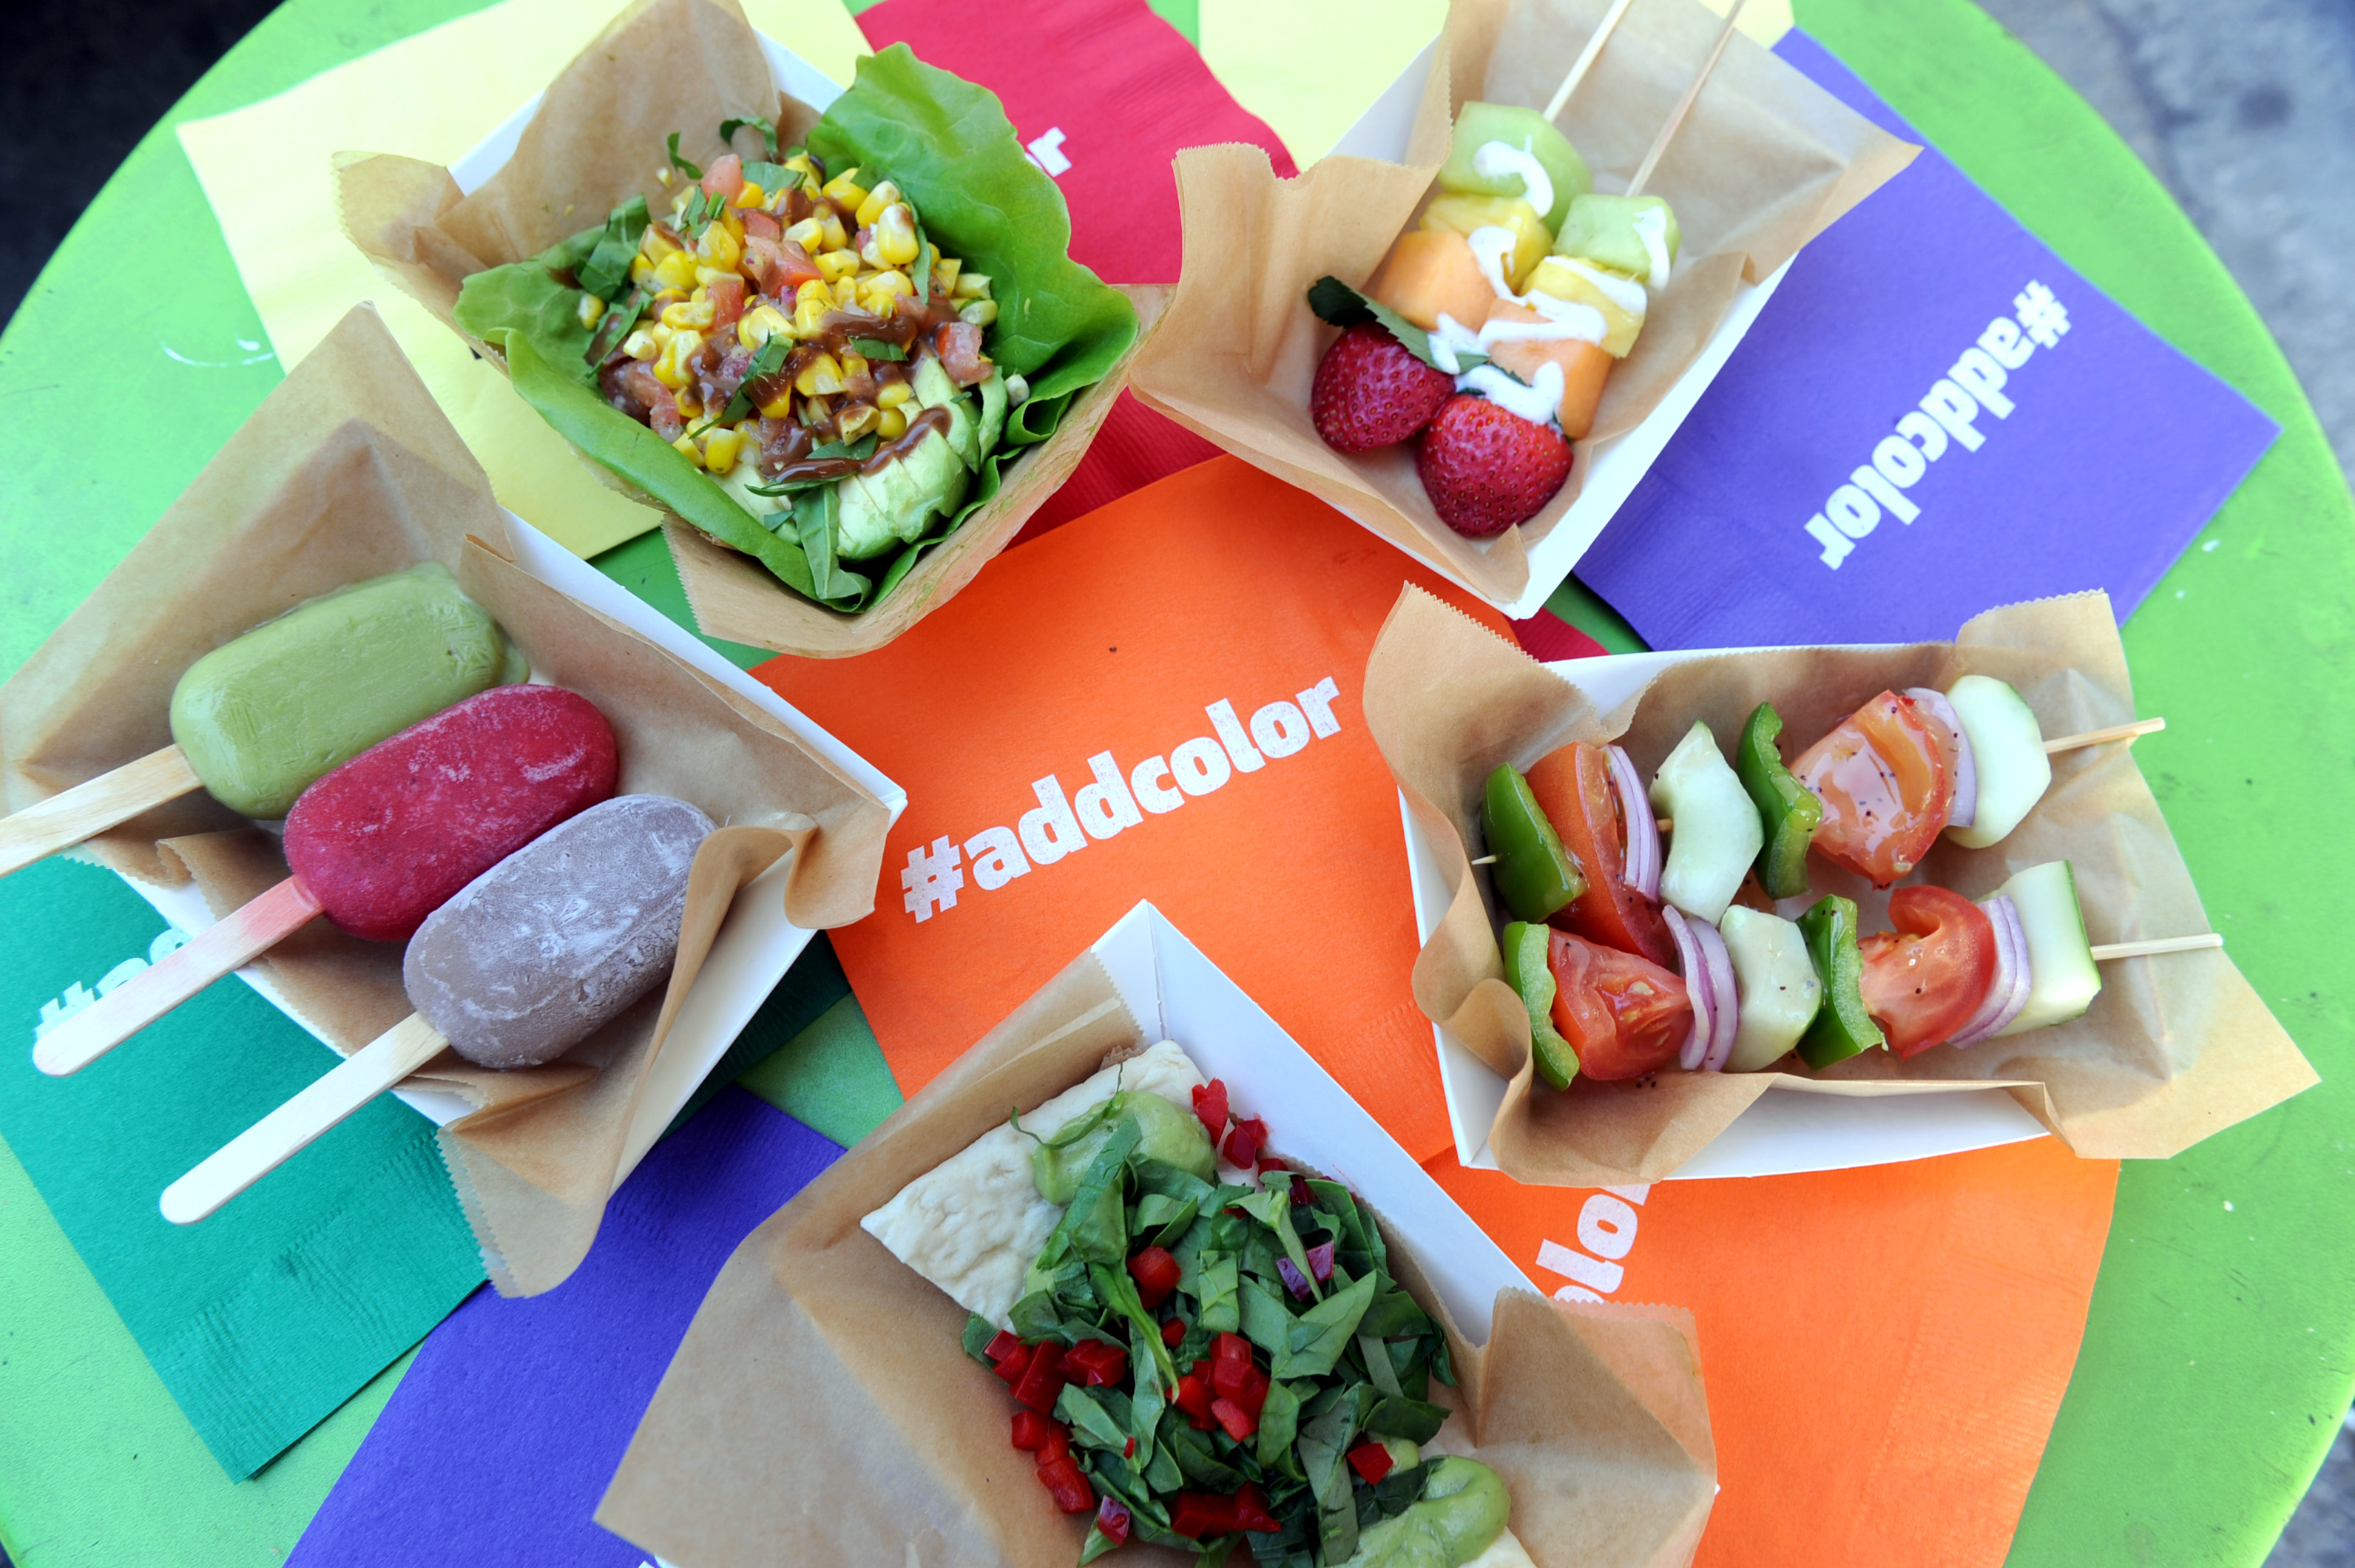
[1399,647,2044,1182]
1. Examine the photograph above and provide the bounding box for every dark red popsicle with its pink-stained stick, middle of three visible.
[33,685,619,1076]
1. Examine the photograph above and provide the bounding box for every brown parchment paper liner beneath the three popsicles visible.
[0,306,888,1295]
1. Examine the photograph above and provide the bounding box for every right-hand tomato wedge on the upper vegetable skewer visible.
[1799,692,1955,888]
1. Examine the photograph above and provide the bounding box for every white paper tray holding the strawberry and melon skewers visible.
[1328,40,1790,621]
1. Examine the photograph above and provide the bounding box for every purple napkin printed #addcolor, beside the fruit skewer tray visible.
[1578,33,2275,647]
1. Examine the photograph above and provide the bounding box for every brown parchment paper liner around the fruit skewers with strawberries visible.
[1135,0,1919,605]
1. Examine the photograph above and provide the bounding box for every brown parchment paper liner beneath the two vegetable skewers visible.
[1366,589,2317,1186]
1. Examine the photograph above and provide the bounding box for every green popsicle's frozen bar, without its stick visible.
[172,563,525,817]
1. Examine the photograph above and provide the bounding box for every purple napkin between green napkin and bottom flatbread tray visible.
[290,1088,841,1568]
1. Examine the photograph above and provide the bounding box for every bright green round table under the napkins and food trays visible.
[0,0,2355,1568]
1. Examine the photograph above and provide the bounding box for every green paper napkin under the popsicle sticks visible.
[0,859,483,1479]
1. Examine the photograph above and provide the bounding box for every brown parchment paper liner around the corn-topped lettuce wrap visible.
[337,0,1170,659]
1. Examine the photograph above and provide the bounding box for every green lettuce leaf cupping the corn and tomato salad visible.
[455,44,1138,612]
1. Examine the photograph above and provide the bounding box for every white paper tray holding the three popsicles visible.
[98,501,907,1184]
